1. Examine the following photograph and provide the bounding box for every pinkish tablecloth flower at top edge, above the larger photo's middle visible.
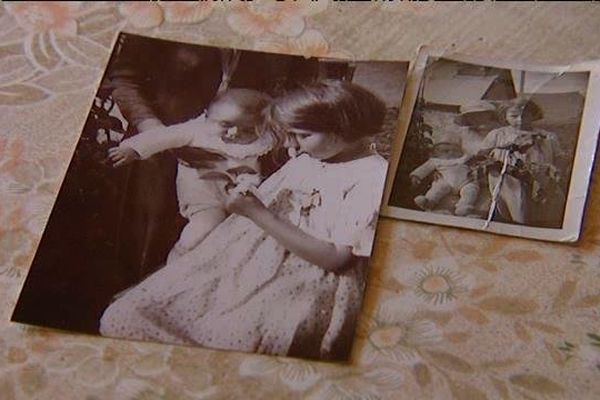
[227,0,327,36]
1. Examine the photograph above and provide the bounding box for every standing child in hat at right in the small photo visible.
[480,98,564,224]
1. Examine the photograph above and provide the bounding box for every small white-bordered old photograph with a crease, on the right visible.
[384,54,598,241]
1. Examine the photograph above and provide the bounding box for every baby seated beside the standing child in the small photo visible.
[410,142,479,216]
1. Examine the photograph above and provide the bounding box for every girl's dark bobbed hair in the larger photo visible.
[265,80,386,142]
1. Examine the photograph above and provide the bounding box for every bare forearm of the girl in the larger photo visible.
[227,194,355,272]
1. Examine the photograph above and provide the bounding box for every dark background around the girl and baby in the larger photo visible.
[12,34,408,333]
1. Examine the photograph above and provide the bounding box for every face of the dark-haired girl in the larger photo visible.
[285,129,348,160]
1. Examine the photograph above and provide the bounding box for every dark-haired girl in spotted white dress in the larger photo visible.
[100,81,387,359]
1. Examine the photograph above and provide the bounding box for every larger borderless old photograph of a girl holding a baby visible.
[12,34,408,361]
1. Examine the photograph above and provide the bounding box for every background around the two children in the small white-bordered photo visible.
[388,58,587,228]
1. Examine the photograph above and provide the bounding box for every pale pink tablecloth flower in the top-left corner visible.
[5,1,81,36]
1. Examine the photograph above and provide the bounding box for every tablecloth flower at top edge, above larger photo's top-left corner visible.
[119,1,215,29]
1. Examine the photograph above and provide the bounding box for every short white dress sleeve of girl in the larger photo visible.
[333,159,387,257]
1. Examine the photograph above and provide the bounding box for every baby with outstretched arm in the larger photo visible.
[109,89,274,261]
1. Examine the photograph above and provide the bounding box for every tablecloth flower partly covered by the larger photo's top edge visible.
[254,29,354,59]
